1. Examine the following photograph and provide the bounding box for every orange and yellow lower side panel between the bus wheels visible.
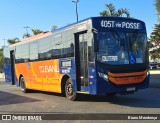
[16,60,63,93]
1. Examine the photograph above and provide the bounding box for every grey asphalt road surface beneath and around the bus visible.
[0,70,160,121]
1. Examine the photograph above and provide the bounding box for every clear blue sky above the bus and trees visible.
[0,0,158,47]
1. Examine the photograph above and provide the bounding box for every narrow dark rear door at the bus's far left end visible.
[10,50,15,85]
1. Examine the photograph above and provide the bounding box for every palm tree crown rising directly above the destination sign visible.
[99,3,130,17]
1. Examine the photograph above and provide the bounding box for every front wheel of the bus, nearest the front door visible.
[65,78,77,101]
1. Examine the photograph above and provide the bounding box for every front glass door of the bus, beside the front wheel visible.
[75,32,89,91]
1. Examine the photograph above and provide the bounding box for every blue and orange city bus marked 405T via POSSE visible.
[4,17,150,100]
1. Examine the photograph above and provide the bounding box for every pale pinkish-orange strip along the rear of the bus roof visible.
[9,32,52,47]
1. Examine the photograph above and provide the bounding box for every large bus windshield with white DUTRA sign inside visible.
[97,31,148,65]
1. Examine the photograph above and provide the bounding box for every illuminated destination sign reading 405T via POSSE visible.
[101,20,141,29]
